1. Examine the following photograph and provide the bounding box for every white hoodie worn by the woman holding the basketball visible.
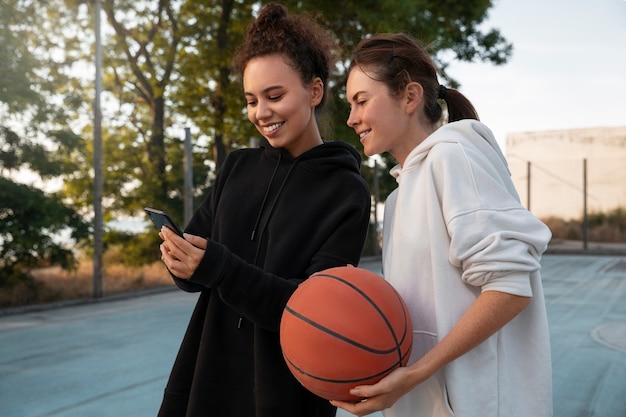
[383,120,552,417]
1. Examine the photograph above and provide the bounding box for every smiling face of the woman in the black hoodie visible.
[243,55,324,157]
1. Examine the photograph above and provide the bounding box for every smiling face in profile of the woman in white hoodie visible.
[346,67,415,163]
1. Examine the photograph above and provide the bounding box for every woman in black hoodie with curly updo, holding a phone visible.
[159,3,370,417]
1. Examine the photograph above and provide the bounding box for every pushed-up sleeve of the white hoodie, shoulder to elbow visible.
[430,138,551,296]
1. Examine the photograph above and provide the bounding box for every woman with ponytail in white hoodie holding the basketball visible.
[333,34,552,417]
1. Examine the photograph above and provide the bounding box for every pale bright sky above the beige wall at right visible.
[448,0,626,150]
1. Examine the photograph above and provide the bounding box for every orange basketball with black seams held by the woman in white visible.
[280,266,413,401]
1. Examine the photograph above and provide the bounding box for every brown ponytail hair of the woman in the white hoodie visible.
[349,33,478,124]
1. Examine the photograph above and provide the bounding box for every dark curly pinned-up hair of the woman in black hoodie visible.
[233,3,337,110]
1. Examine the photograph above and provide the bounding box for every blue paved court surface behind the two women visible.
[0,251,626,417]
